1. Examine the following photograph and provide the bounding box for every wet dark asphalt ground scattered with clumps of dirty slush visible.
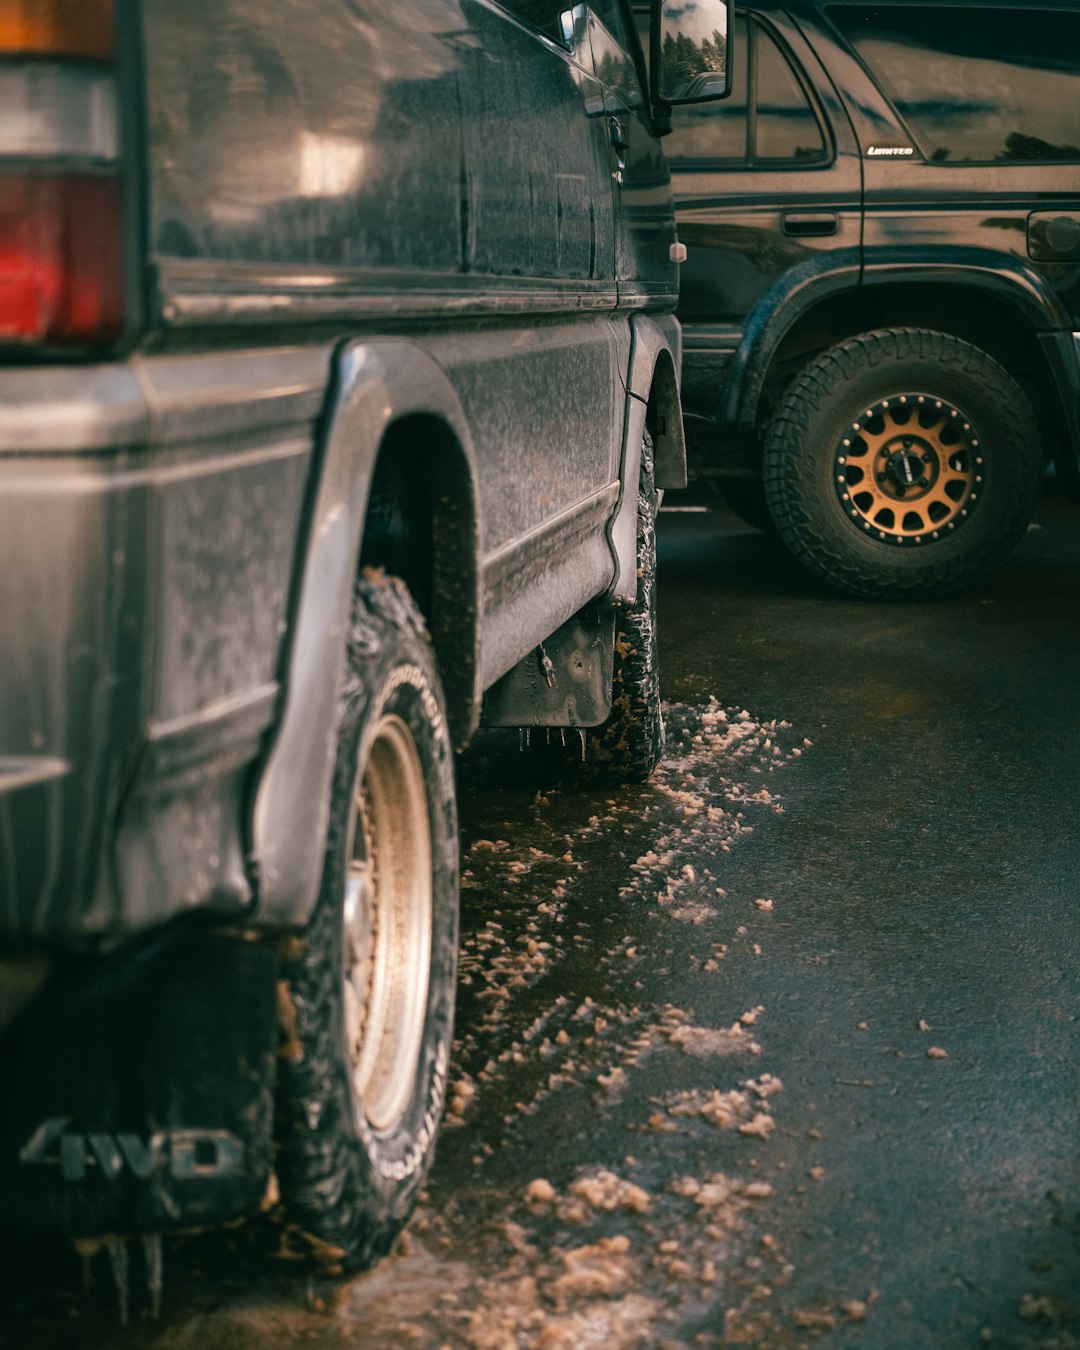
[0,498,1080,1350]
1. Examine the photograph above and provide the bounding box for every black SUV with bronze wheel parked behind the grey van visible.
[666,0,1080,597]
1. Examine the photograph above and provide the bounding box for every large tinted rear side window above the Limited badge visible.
[829,5,1080,163]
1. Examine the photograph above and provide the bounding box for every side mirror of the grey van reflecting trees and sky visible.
[649,0,734,107]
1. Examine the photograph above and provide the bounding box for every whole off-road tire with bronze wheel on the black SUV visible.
[763,328,1044,598]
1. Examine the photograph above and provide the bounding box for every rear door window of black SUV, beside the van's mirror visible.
[664,15,825,165]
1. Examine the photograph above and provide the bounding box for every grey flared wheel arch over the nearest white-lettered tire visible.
[248,340,478,926]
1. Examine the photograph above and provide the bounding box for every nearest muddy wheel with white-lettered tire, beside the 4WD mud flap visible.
[275,574,458,1269]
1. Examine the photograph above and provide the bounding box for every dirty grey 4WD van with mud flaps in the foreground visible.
[0,0,729,1285]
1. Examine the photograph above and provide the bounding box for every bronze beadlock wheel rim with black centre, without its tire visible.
[836,393,986,545]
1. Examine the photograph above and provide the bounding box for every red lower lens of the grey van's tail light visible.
[0,173,123,344]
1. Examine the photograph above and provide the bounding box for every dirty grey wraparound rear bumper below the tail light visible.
[0,348,328,948]
